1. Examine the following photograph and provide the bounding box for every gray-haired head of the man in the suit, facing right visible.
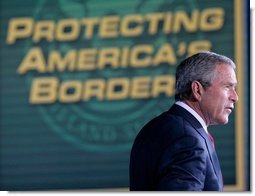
[175,52,238,125]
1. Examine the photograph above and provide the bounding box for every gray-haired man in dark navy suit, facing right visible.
[130,52,238,191]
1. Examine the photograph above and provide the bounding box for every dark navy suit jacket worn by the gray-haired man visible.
[129,104,223,191]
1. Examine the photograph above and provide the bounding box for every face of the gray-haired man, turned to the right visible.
[200,64,238,125]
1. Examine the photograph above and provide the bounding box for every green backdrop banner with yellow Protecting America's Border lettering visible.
[0,0,247,190]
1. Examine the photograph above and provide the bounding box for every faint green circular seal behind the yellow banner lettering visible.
[22,0,201,152]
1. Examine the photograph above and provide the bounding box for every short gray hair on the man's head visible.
[175,51,236,101]
